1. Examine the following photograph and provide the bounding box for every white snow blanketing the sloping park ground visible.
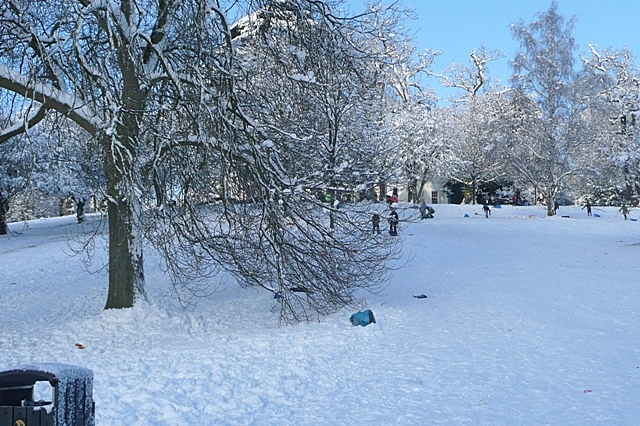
[0,204,640,426]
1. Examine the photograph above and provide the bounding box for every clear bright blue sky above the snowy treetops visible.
[345,0,640,98]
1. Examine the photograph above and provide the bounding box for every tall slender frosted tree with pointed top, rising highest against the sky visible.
[505,1,582,216]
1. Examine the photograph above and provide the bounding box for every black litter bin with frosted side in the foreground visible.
[0,363,95,426]
